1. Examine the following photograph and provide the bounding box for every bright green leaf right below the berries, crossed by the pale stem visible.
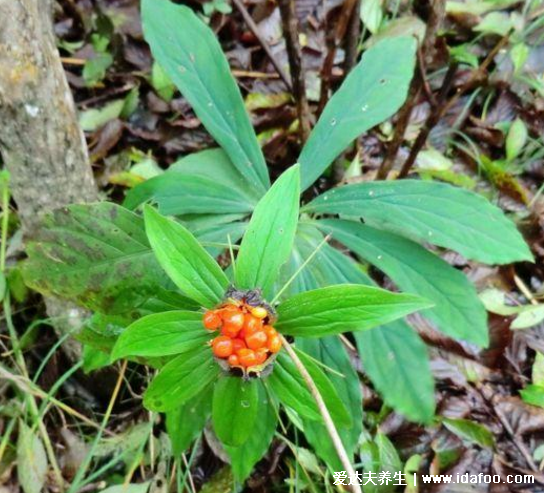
[268,350,352,427]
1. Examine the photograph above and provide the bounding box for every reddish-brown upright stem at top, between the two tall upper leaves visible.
[278,0,311,143]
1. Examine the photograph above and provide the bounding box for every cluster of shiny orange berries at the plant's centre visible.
[203,301,281,369]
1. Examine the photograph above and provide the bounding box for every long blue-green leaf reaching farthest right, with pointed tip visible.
[304,180,533,264]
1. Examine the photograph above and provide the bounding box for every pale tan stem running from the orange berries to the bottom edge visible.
[280,334,362,493]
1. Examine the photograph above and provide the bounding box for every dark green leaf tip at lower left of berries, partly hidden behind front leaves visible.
[166,385,213,456]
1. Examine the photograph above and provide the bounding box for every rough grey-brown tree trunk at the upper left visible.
[0,0,97,358]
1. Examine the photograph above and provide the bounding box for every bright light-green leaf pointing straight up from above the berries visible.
[235,166,300,296]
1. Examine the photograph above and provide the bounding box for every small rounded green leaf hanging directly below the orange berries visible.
[212,376,260,447]
